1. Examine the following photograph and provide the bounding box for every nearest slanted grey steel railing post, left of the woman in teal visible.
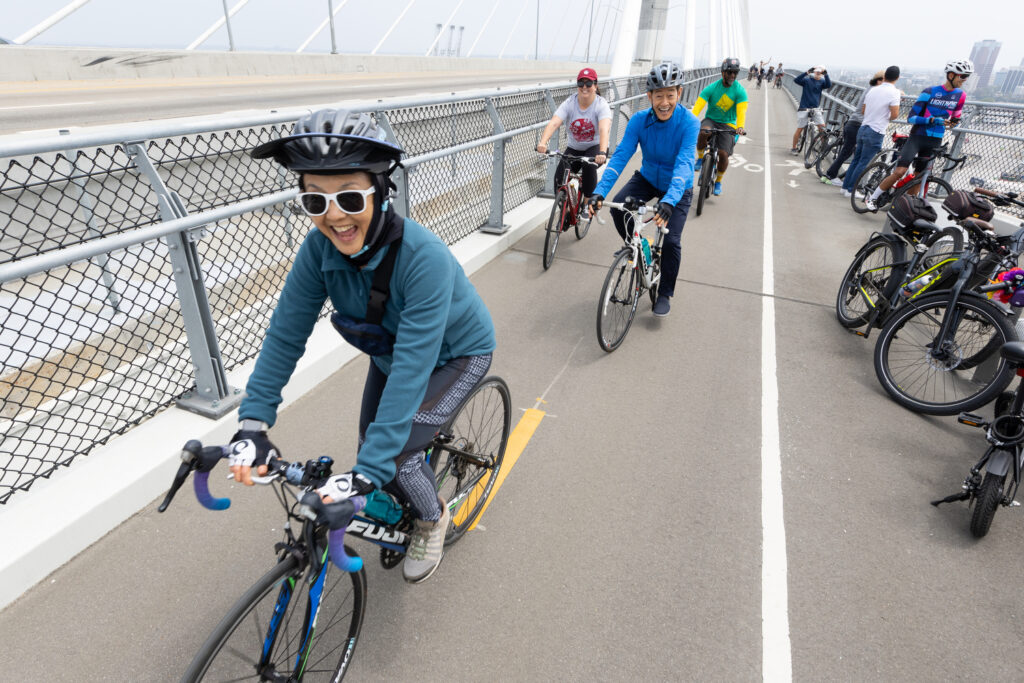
[124,142,242,419]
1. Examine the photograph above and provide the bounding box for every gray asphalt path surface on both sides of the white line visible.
[0,90,1024,681]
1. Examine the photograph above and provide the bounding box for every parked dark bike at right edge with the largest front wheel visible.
[874,218,1024,415]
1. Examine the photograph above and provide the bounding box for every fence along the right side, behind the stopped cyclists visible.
[782,71,1024,218]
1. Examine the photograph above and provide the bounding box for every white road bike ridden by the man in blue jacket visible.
[597,198,669,353]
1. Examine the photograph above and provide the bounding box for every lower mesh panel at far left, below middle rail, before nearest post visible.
[0,242,191,503]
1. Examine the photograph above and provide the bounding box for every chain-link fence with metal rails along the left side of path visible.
[0,69,717,504]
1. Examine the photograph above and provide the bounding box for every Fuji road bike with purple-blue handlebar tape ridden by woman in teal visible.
[159,377,512,683]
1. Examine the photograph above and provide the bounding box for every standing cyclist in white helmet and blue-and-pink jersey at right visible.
[864,59,974,211]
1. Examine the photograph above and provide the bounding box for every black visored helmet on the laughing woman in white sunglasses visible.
[251,110,402,176]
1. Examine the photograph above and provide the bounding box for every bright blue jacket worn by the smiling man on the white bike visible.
[594,104,700,206]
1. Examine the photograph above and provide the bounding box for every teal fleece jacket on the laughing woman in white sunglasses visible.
[239,218,495,487]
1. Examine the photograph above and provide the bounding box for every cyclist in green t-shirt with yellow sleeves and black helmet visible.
[691,57,748,195]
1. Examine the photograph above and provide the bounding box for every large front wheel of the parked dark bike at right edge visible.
[874,292,1017,415]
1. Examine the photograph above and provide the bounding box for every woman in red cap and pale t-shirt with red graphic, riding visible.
[537,67,611,206]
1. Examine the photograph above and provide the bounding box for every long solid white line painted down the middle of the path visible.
[761,82,793,683]
